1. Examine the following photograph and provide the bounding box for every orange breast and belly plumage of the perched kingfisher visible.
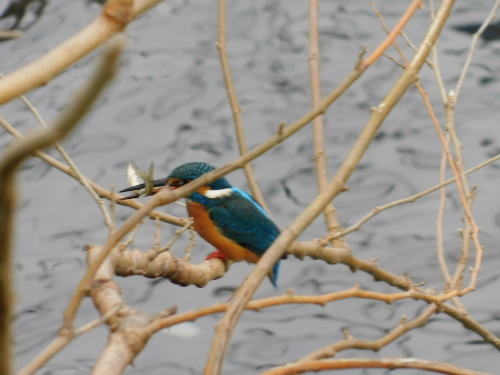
[187,202,259,263]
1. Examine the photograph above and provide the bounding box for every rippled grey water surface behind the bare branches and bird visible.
[0,0,500,375]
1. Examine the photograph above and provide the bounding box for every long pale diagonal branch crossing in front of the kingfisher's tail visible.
[205,0,454,375]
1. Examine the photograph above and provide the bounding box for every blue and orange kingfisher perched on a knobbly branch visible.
[120,162,280,289]
